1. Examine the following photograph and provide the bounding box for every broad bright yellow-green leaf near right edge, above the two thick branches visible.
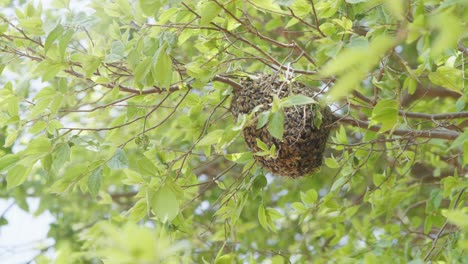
[429,66,463,94]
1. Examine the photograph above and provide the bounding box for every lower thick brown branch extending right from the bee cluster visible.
[337,115,461,140]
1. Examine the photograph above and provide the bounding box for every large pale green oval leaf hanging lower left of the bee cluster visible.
[151,185,179,222]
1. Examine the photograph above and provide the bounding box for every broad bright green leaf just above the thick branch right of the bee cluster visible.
[369,99,398,132]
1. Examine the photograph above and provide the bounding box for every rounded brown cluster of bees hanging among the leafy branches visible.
[231,75,335,178]
